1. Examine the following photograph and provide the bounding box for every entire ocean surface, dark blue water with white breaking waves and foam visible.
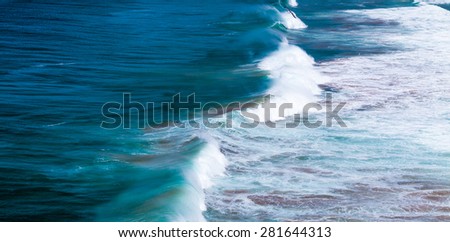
[0,0,450,221]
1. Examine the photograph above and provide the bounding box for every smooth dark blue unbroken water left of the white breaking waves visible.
[0,1,282,221]
